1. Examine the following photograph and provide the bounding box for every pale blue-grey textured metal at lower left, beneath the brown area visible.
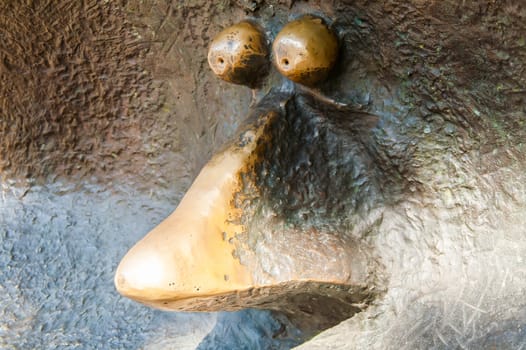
[0,184,303,350]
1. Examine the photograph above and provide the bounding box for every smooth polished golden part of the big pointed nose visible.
[115,102,276,309]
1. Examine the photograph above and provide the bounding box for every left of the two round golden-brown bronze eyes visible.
[208,21,269,88]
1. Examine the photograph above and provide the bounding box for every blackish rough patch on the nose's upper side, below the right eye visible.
[254,95,384,232]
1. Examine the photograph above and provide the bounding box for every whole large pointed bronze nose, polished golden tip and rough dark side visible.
[115,93,374,314]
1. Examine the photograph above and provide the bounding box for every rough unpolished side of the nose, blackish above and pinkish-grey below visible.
[233,92,386,292]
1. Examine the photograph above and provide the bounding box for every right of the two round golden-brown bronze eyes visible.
[272,16,338,86]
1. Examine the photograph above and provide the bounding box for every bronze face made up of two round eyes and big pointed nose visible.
[115,16,381,320]
